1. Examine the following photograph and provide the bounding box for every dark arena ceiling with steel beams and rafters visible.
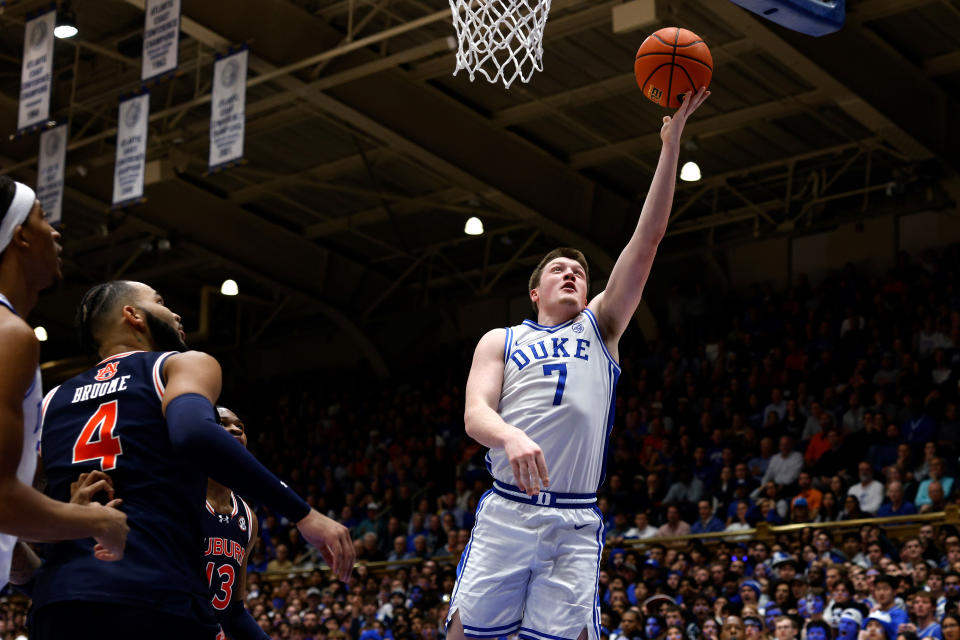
[0,0,960,372]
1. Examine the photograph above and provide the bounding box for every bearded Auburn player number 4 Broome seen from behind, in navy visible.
[33,281,354,640]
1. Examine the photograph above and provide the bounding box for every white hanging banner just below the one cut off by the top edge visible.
[113,93,150,207]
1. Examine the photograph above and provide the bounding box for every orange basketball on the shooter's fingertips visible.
[633,27,713,109]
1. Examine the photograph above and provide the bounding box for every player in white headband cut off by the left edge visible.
[0,176,127,589]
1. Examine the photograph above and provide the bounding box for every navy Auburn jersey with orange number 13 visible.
[203,491,252,617]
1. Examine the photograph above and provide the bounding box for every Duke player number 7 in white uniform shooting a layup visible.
[447,88,709,640]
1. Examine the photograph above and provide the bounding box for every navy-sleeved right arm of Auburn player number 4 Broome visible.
[163,351,356,580]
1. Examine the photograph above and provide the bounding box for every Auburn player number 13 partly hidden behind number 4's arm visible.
[203,407,270,640]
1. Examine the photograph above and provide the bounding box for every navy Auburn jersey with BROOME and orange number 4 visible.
[33,351,216,625]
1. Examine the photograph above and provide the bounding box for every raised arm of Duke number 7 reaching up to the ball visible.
[589,88,710,344]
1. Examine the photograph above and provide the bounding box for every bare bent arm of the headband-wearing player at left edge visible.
[0,317,129,560]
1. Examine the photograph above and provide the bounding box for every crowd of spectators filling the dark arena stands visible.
[0,248,960,640]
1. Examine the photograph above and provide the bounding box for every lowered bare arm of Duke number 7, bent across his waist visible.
[463,329,550,496]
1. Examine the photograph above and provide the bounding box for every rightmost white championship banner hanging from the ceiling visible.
[210,49,247,169]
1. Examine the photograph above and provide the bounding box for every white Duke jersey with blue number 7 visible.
[487,309,620,494]
